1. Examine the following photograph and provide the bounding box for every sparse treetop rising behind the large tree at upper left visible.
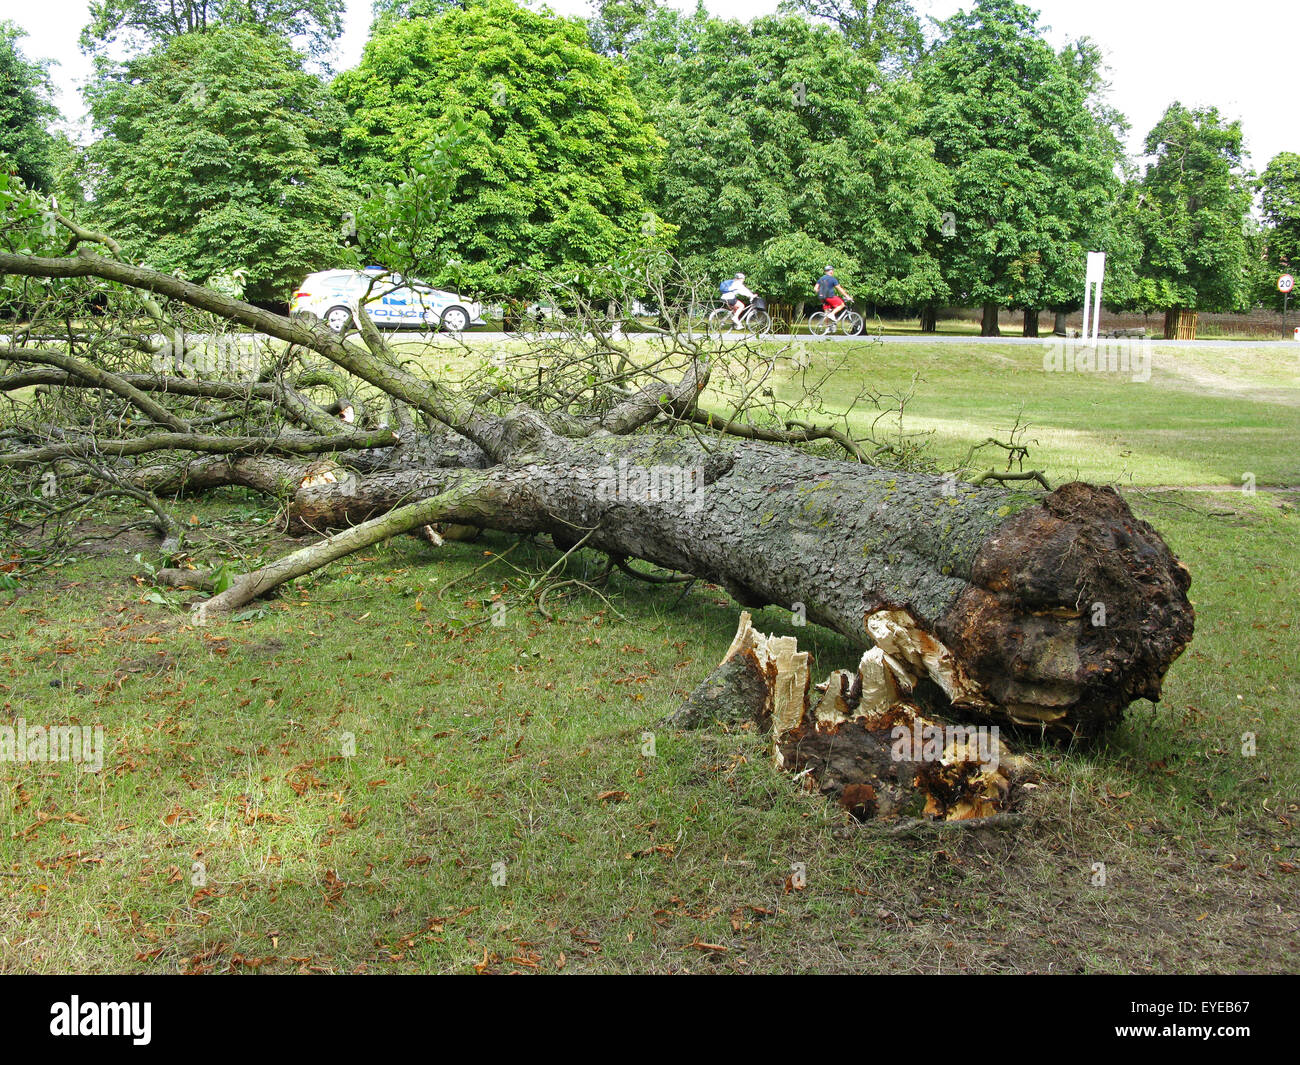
[82,0,347,56]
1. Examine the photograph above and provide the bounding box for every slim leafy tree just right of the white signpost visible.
[1136,103,1251,311]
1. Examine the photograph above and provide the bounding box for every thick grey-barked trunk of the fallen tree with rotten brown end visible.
[208,434,1193,736]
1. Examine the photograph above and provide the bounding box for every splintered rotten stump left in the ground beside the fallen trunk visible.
[668,611,1028,821]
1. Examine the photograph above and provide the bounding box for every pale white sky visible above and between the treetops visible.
[10,0,1300,170]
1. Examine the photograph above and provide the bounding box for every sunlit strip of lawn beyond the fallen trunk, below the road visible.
[754,341,1300,486]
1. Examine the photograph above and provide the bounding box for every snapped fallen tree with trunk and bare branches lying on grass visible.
[0,185,1193,736]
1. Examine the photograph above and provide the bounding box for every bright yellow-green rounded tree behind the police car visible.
[335,0,660,294]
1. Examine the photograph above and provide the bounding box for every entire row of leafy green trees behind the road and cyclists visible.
[0,0,1300,334]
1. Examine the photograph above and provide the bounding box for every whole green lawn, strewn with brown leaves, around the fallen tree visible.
[0,343,1300,973]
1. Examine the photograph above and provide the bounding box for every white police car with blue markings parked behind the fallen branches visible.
[290,267,484,333]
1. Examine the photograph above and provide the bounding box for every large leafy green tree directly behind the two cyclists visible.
[628,9,945,304]
